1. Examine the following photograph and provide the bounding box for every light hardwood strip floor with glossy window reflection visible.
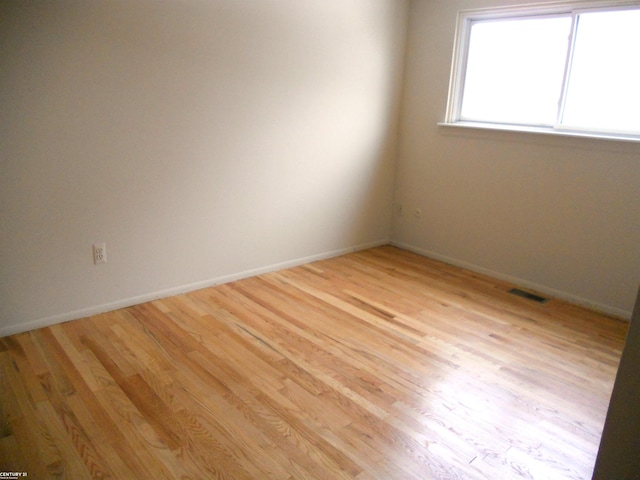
[0,247,628,480]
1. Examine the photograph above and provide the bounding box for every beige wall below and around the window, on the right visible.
[392,0,640,317]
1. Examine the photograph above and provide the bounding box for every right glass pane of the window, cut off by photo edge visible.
[562,10,640,133]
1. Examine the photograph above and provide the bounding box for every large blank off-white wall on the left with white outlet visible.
[0,0,407,335]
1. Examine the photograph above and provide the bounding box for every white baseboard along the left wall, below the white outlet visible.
[0,239,389,337]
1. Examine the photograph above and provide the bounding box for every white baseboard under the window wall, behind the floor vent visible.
[390,241,631,320]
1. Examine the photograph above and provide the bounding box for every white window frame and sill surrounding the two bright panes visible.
[438,0,640,142]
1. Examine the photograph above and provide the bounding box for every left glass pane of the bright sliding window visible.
[460,16,571,126]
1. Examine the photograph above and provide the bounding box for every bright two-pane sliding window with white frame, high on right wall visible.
[446,1,640,140]
